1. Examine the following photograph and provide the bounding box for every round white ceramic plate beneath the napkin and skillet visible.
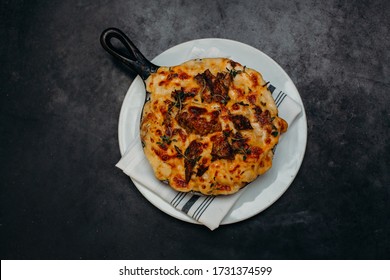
[118,39,307,224]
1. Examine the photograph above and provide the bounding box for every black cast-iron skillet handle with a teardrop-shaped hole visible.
[100,27,159,80]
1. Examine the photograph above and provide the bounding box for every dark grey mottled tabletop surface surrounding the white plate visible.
[0,0,390,259]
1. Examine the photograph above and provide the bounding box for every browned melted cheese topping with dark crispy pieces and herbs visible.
[141,58,287,195]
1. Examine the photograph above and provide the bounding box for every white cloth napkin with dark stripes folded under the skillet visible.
[116,49,301,230]
